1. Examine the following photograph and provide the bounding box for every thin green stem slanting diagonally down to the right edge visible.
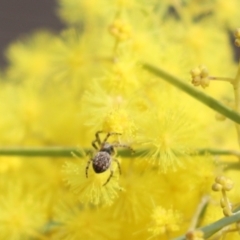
[142,63,240,123]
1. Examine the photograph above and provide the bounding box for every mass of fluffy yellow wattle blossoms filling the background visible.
[0,0,240,240]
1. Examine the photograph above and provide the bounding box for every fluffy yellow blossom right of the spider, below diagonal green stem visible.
[135,94,201,172]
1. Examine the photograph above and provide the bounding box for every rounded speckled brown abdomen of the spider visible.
[92,151,111,173]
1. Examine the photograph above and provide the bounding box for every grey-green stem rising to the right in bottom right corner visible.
[174,212,240,240]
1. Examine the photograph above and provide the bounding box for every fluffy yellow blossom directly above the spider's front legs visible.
[81,79,136,138]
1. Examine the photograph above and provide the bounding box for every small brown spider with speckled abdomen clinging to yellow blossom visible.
[86,131,133,186]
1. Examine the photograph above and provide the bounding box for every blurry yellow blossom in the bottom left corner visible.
[0,180,47,240]
